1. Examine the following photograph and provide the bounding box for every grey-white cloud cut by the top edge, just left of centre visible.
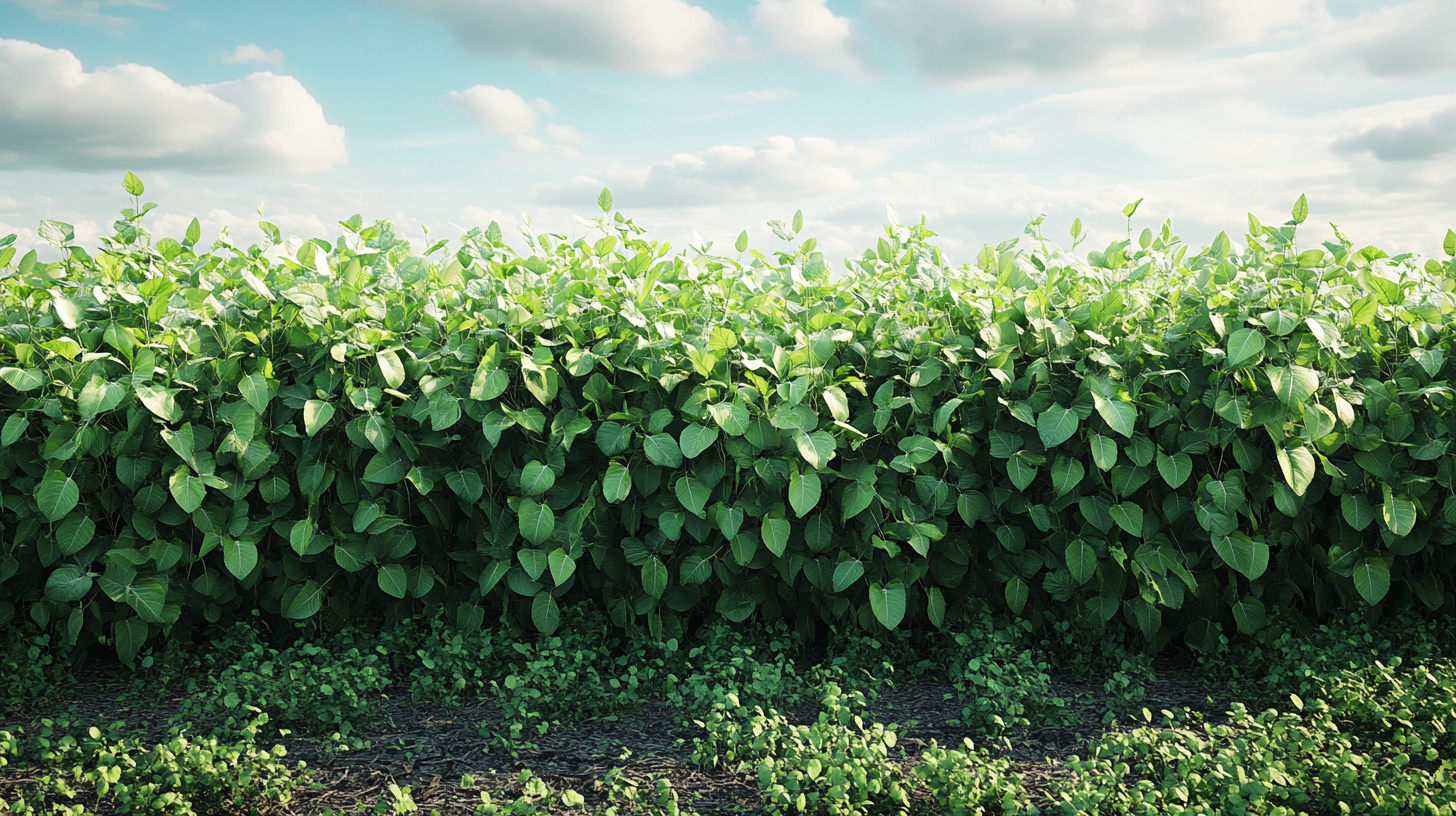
[384,0,735,76]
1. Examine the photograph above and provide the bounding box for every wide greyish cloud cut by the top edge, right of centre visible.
[865,0,1319,82]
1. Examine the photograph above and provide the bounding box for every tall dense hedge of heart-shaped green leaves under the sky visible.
[0,173,1456,662]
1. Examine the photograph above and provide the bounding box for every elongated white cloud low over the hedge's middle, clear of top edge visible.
[539,136,887,208]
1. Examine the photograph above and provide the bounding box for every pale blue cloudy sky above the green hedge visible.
[0,0,1456,262]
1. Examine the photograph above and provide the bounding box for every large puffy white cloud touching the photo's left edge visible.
[0,39,348,173]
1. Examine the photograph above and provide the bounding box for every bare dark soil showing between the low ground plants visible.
[0,655,1227,816]
